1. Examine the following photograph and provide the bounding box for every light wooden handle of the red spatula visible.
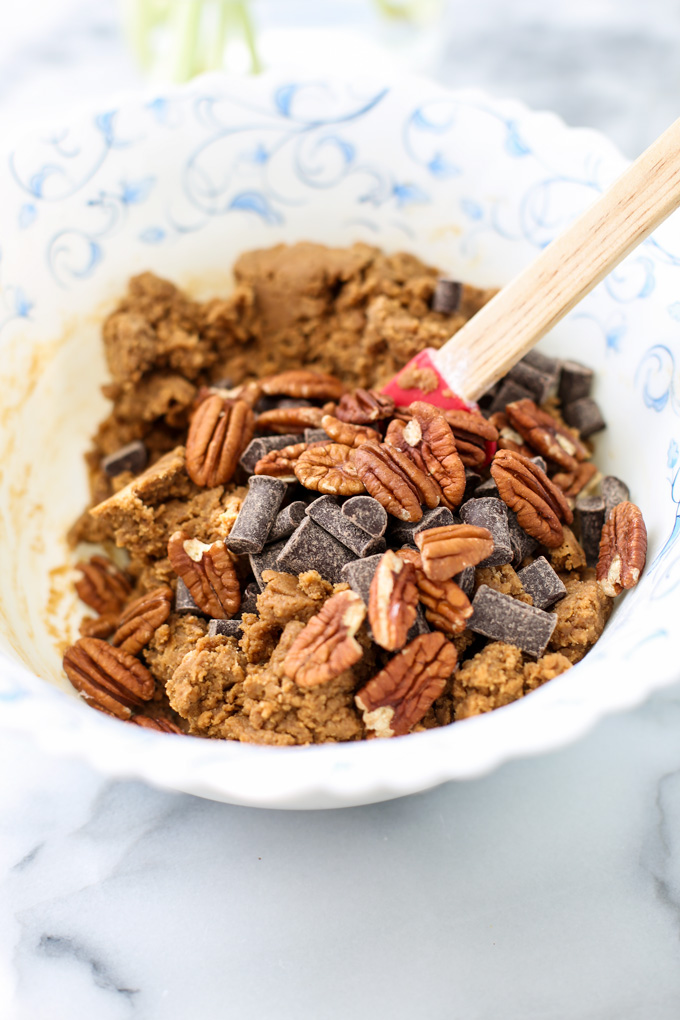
[433,119,680,401]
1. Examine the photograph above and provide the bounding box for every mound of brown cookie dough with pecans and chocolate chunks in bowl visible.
[64,244,646,746]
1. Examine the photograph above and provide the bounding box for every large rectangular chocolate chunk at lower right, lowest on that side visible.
[468,584,558,659]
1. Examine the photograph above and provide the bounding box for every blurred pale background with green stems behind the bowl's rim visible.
[0,0,680,156]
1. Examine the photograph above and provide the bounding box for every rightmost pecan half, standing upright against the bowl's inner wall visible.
[596,501,647,598]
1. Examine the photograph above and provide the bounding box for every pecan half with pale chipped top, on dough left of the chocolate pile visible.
[167,531,241,620]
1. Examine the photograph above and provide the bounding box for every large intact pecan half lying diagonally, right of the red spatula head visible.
[491,450,574,549]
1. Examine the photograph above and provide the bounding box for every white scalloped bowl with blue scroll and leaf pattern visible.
[0,75,680,808]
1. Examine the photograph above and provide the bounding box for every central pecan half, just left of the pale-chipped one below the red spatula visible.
[355,442,441,521]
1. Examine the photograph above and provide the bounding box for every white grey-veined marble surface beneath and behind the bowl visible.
[0,0,680,1020]
